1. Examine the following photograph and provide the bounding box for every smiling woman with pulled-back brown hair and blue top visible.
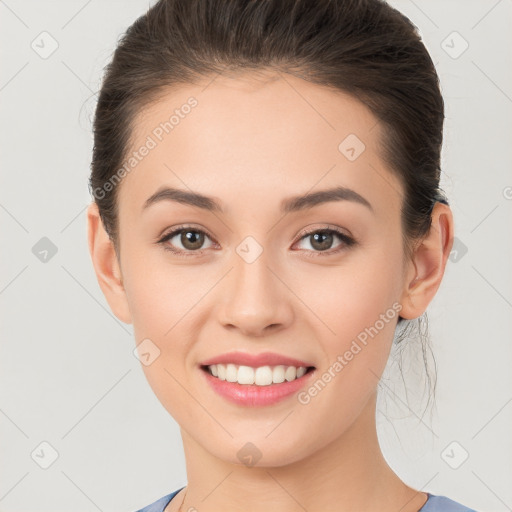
[88,0,476,512]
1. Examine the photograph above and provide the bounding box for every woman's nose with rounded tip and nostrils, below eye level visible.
[219,251,293,337]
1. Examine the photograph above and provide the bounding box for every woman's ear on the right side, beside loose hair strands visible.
[400,202,453,320]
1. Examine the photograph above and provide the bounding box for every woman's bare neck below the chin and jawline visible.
[172,394,427,512]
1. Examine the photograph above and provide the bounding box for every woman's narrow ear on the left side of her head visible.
[87,201,131,324]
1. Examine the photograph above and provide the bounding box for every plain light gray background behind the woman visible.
[0,0,512,512]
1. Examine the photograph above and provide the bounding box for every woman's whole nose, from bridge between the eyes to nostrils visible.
[221,241,292,336]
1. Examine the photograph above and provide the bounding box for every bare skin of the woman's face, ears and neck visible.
[87,73,453,512]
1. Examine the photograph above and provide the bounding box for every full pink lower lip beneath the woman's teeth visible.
[201,369,315,407]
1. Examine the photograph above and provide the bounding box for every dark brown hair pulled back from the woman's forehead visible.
[89,0,447,410]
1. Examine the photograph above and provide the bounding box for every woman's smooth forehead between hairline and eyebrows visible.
[119,73,401,218]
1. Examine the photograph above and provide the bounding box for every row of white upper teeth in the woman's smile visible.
[208,363,307,386]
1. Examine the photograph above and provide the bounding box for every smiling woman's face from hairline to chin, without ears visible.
[112,75,412,466]
